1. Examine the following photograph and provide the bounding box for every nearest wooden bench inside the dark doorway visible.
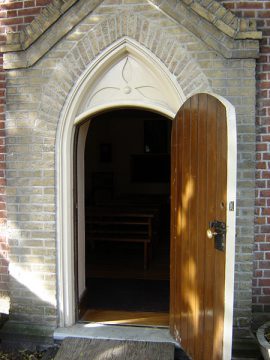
[86,206,157,269]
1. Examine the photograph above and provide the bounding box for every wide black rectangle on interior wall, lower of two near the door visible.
[130,154,171,183]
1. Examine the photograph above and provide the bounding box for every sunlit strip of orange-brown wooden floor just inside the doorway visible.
[81,309,169,327]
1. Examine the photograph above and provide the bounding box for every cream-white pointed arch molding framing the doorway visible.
[55,38,185,326]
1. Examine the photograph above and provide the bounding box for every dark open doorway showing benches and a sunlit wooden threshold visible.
[79,109,171,326]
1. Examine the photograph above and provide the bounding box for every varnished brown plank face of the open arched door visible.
[170,94,227,360]
